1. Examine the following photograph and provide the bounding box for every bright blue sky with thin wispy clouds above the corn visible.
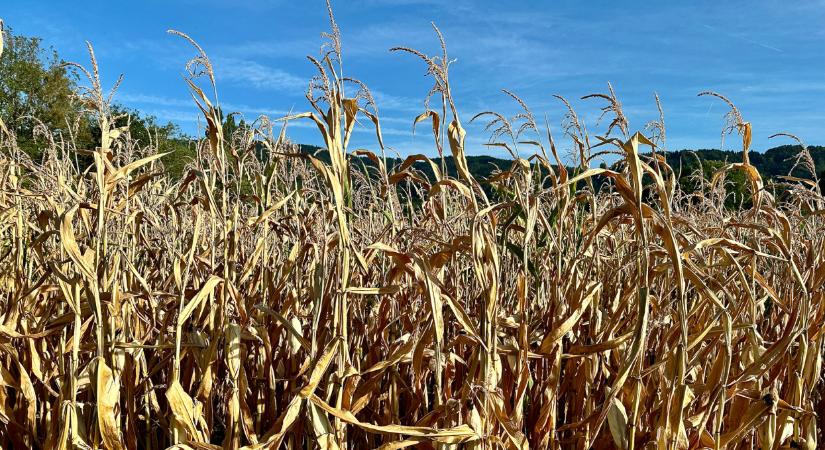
[2,0,825,162]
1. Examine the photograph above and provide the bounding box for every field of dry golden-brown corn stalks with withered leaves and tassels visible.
[0,4,825,450]
